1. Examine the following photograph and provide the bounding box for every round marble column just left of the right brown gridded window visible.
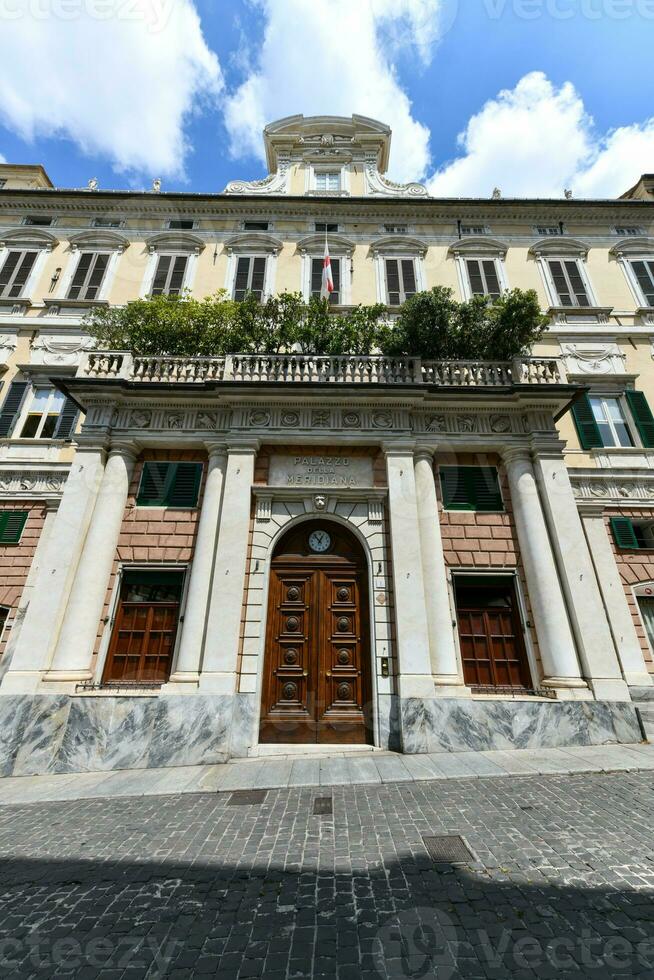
[414,447,469,697]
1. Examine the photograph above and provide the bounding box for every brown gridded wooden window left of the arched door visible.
[103,570,184,684]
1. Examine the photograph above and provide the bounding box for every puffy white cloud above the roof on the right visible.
[429,72,654,197]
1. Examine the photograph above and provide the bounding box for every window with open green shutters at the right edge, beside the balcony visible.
[572,390,654,449]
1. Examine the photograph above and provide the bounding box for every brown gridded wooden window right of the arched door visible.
[456,578,532,690]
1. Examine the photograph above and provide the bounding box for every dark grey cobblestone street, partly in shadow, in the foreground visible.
[0,773,654,980]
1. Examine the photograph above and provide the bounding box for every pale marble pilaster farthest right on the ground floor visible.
[582,504,652,687]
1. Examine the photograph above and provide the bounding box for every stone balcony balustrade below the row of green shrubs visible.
[76,351,568,388]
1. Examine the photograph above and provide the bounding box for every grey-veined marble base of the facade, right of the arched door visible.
[400,698,643,754]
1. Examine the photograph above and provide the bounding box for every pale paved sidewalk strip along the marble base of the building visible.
[0,744,654,806]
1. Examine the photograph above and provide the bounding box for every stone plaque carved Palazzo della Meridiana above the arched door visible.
[268,455,373,490]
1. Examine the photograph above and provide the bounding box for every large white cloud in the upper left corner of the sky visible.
[0,0,223,176]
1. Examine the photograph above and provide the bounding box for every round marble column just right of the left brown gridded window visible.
[162,443,227,694]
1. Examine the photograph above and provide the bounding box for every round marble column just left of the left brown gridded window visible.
[43,443,137,685]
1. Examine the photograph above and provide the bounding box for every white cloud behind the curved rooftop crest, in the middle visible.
[225,0,443,180]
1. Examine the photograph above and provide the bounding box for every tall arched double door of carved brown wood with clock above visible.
[259,520,373,744]
